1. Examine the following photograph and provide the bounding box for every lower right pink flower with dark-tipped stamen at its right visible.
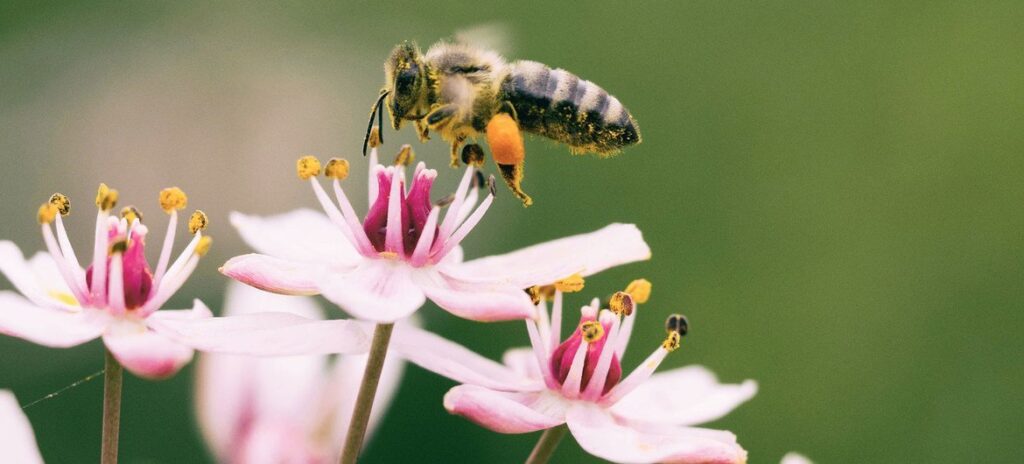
[392,281,757,463]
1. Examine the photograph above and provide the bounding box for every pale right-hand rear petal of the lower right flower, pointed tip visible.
[611,366,758,425]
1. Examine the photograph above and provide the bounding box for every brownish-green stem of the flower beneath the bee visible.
[340,324,394,464]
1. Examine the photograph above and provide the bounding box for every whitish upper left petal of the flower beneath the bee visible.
[230,208,360,265]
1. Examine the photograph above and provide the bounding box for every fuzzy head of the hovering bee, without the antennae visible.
[384,41,427,129]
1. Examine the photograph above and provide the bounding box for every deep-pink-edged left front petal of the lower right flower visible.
[444,385,568,433]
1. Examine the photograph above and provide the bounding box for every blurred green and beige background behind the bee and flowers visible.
[0,1,1024,463]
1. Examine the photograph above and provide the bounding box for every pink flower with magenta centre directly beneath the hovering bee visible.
[221,146,650,323]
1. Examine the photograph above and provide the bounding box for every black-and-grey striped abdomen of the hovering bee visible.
[501,61,640,155]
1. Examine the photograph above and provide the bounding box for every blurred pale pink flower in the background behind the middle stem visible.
[196,284,402,464]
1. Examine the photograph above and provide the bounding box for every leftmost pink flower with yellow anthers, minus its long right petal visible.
[0,183,211,378]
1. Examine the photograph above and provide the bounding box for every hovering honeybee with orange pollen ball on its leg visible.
[364,41,640,206]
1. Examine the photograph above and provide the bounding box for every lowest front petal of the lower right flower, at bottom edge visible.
[565,402,746,464]
